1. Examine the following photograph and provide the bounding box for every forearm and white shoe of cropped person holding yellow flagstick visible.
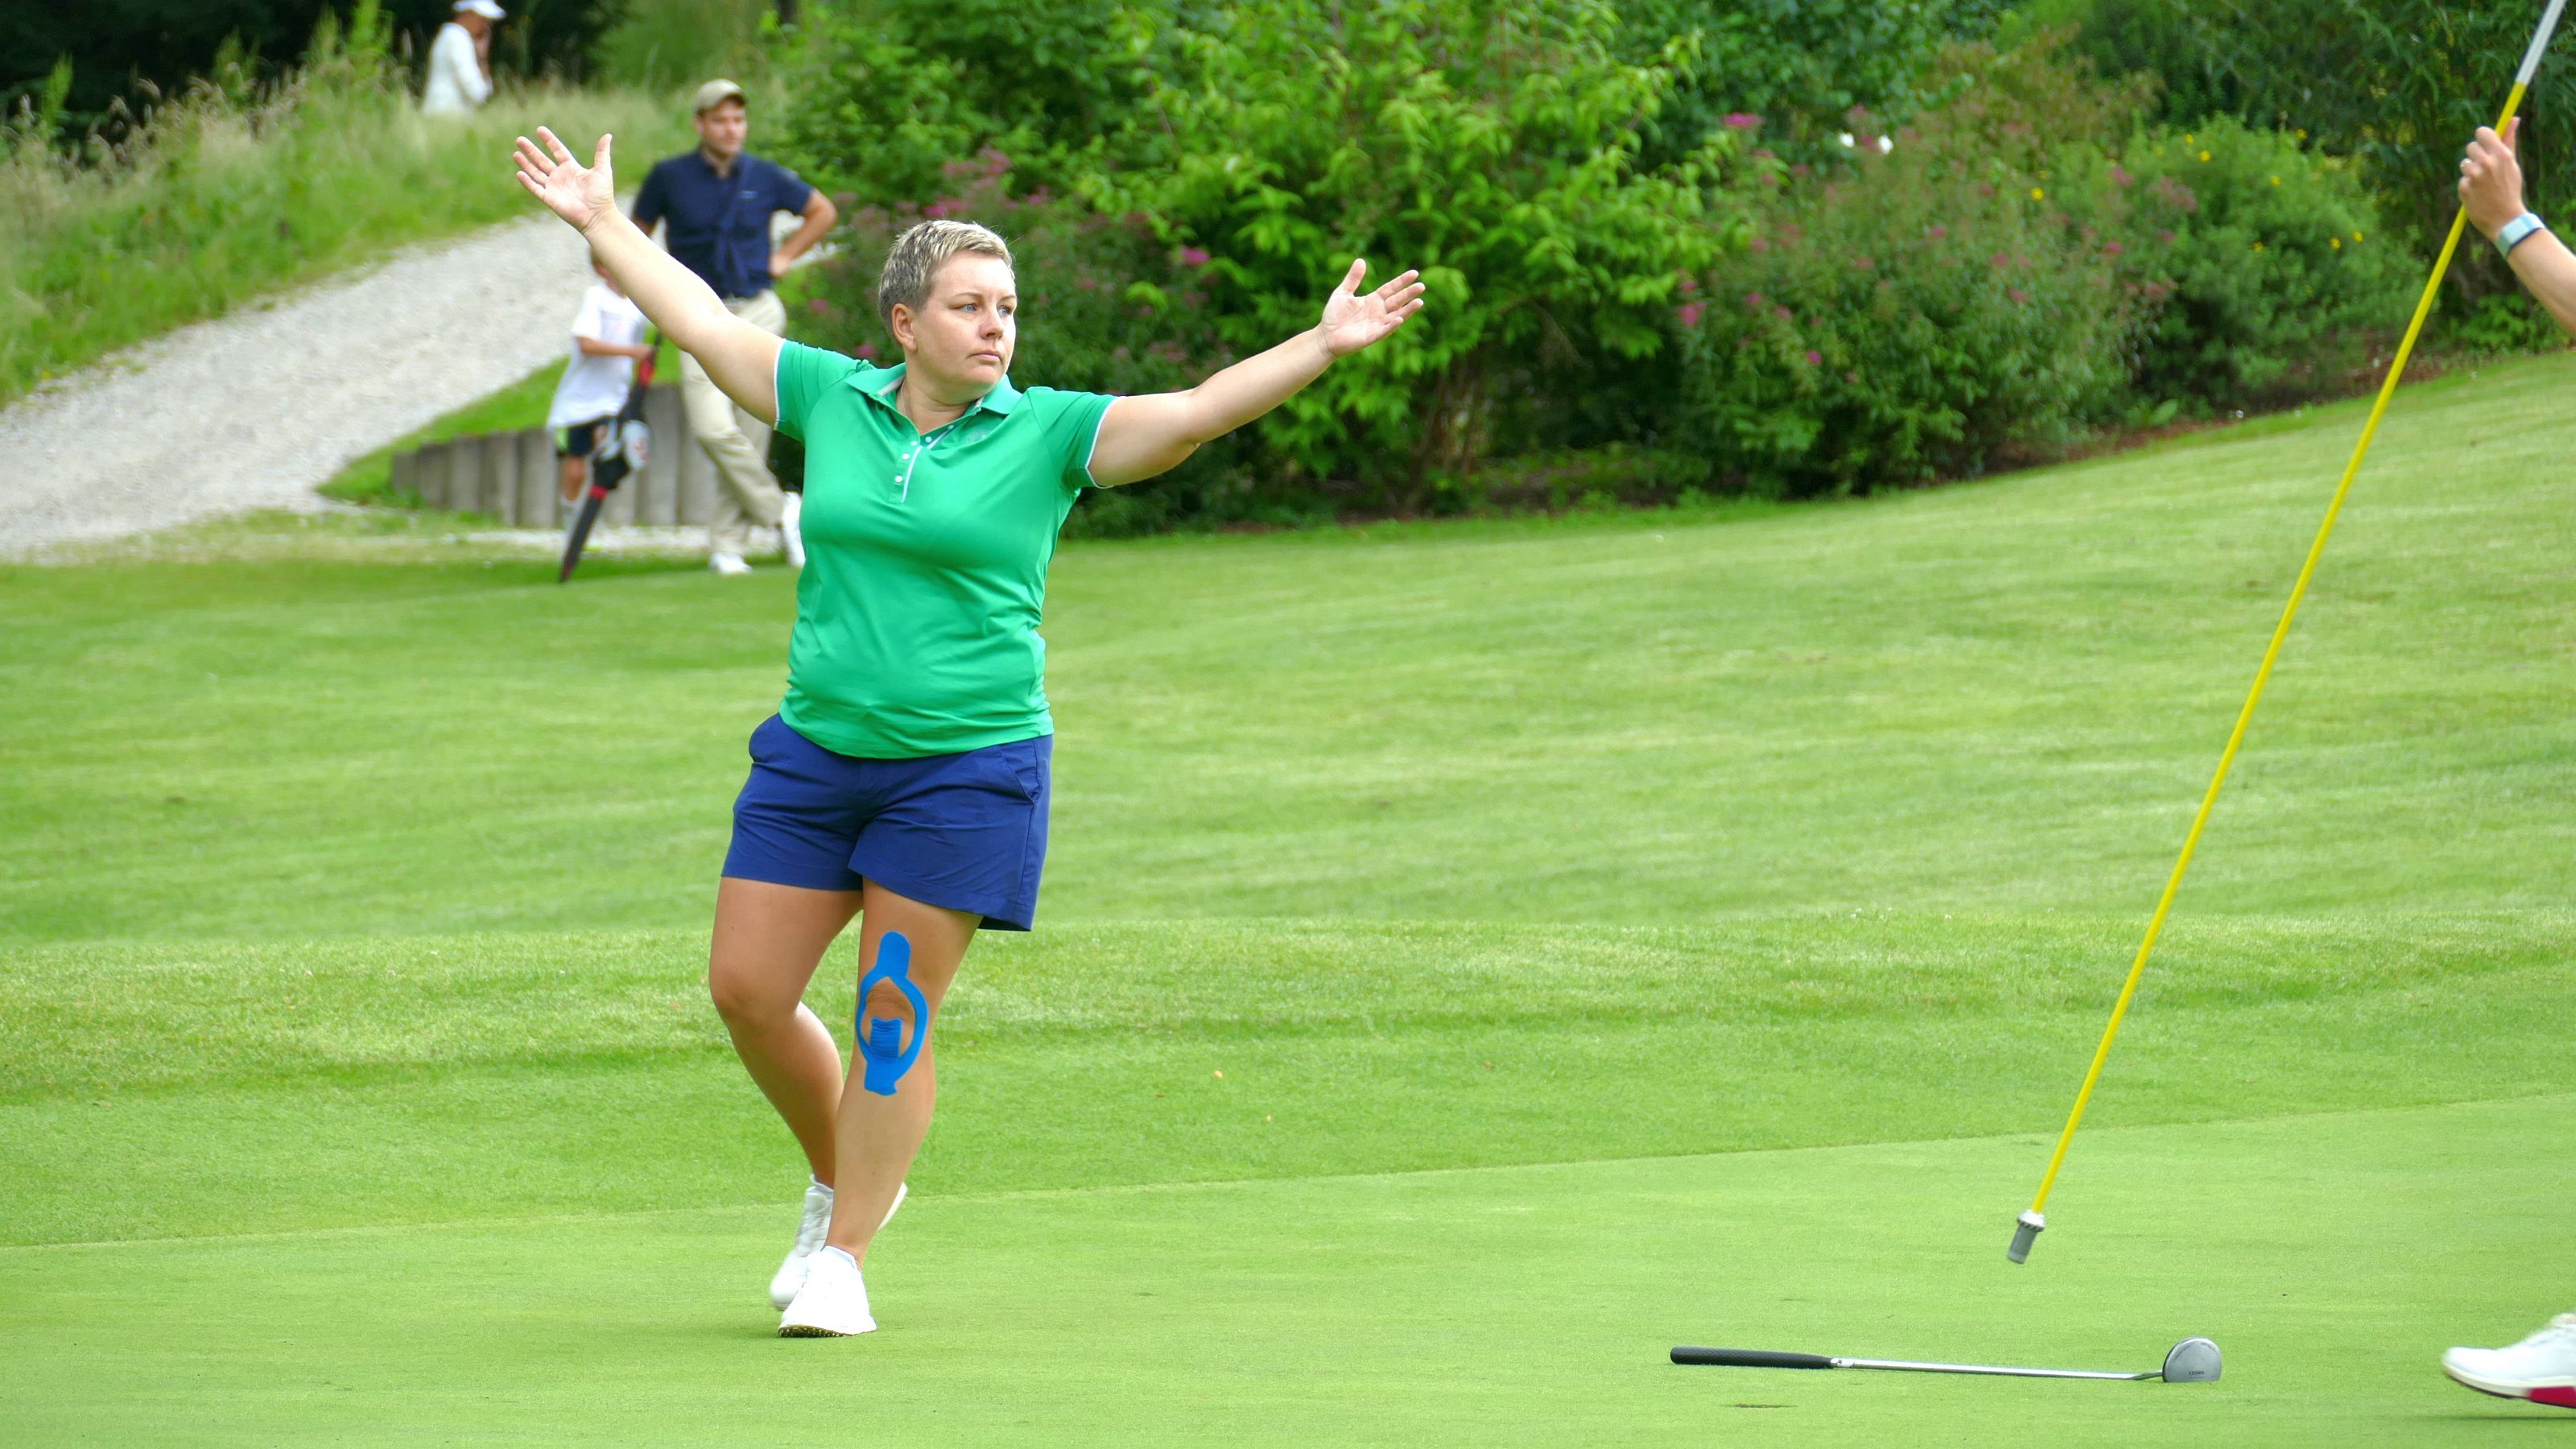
[2442,122,2576,1408]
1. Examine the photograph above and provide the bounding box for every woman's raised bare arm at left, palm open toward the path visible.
[515,126,778,423]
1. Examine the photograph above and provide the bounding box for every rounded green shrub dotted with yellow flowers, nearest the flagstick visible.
[2117,116,2421,412]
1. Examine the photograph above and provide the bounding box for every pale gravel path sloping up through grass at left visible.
[0,217,590,557]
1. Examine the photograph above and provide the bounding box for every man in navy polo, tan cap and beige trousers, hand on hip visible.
[634,80,840,572]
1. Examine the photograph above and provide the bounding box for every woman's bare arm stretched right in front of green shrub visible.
[1087,260,1422,487]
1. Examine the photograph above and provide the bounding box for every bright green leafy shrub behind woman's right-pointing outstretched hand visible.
[1082,0,1744,510]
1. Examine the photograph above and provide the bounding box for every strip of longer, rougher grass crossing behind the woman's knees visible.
[0,913,2576,1101]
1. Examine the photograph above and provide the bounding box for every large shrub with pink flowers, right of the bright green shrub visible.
[1674,47,2146,497]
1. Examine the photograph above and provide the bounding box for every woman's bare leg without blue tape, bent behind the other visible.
[706,877,860,1180]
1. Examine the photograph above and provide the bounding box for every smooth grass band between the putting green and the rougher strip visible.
[0,923,2576,1243]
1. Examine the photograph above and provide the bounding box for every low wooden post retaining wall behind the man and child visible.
[376,382,716,529]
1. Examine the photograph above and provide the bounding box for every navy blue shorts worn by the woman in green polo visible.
[724,714,1056,931]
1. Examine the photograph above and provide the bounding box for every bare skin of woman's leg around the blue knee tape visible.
[824,881,984,1266]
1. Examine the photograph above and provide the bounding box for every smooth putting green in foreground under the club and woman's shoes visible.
[0,1096,2576,1447]
